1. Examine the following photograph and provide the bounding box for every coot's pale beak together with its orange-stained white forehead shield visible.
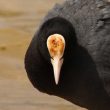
[47,34,65,84]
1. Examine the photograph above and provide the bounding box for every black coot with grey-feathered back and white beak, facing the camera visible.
[25,0,110,110]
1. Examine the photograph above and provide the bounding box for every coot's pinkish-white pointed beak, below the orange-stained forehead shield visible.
[51,57,63,85]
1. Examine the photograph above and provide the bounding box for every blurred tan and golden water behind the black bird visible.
[0,0,86,110]
